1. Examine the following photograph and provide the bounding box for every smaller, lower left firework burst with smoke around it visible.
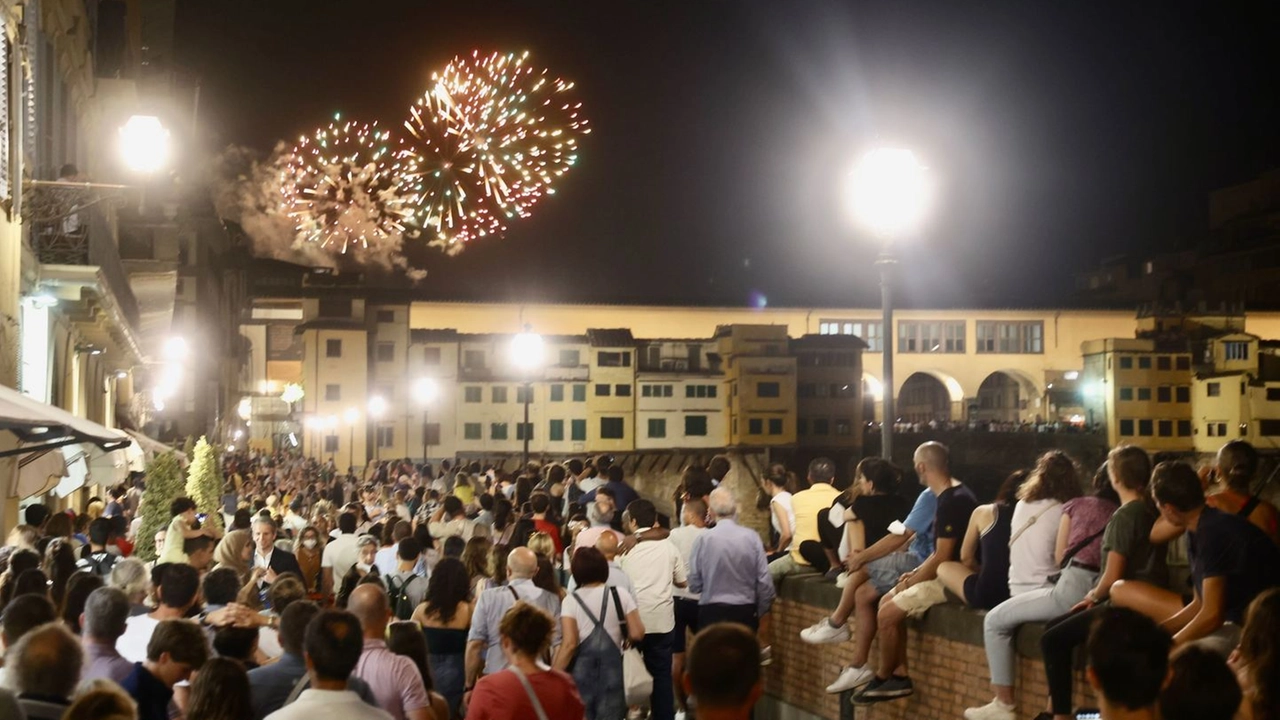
[280,115,411,254]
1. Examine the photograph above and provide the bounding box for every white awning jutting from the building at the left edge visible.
[0,386,133,457]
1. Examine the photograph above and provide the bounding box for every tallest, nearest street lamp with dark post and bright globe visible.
[850,147,928,460]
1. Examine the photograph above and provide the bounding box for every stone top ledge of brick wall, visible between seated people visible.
[778,573,1044,660]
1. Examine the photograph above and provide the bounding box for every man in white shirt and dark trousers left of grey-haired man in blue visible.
[620,498,687,720]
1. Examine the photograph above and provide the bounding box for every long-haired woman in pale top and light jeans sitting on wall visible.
[964,450,1080,720]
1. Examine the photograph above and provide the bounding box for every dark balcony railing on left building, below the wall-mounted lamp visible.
[23,181,138,328]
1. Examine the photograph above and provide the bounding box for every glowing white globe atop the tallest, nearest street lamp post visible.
[850,147,928,237]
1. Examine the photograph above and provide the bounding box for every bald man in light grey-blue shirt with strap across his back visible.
[466,547,559,694]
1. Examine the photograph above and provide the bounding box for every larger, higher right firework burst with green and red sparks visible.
[399,51,590,255]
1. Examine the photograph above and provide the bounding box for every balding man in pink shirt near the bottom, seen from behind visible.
[347,583,431,720]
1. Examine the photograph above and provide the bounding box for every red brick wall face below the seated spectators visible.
[765,577,1097,720]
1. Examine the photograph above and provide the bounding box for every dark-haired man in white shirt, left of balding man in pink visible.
[266,610,392,720]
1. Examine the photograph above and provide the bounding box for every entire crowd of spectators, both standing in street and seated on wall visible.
[0,441,1280,720]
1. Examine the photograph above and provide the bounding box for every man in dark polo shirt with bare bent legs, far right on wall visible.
[1111,462,1280,656]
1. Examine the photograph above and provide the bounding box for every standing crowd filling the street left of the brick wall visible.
[0,452,773,720]
